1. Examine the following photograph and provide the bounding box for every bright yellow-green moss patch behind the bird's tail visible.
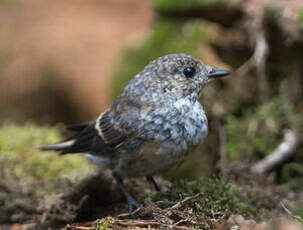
[0,123,89,181]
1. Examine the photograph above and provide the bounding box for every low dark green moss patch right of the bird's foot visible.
[146,177,275,222]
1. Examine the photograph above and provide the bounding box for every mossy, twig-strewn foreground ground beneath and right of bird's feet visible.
[66,176,301,230]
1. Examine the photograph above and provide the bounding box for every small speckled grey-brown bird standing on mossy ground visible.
[42,54,230,213]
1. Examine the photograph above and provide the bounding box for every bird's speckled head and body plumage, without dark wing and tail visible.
[91,55,211,176]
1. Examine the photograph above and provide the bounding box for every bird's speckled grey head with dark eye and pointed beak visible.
[123,54,229,100]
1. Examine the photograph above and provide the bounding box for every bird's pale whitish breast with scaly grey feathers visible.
[142,99,207,149]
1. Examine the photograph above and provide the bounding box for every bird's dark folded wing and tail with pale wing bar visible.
[42,94,139,155]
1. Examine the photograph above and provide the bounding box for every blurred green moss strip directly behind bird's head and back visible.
[113,20,205,97]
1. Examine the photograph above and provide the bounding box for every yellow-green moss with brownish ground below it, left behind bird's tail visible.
[0,123,91,223]
